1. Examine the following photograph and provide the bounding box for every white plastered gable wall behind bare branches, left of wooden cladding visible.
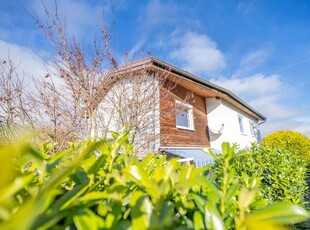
[94,75,160,157]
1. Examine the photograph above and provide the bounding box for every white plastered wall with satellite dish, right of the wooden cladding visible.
[206,98,258,150]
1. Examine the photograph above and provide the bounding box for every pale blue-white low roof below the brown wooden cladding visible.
[163,147,219,167]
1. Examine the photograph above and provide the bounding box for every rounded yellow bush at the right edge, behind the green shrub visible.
[262,130,310,161]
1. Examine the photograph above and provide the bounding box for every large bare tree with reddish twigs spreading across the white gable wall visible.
[32,1,180,151]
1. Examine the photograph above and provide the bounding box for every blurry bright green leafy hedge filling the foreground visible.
[0,133,309,229]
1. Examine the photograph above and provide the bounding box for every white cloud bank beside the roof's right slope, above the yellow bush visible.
[211,74,310,136]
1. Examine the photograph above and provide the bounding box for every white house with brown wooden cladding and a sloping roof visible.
[96,57,266,164]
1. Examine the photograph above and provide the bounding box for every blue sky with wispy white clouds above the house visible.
[0,0,310,137]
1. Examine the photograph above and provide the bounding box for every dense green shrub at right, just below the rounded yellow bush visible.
[217,145,308,206]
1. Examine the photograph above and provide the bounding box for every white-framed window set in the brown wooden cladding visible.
[175,101,194,130]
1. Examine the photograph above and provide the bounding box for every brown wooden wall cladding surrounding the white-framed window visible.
[160,85,210,147]
